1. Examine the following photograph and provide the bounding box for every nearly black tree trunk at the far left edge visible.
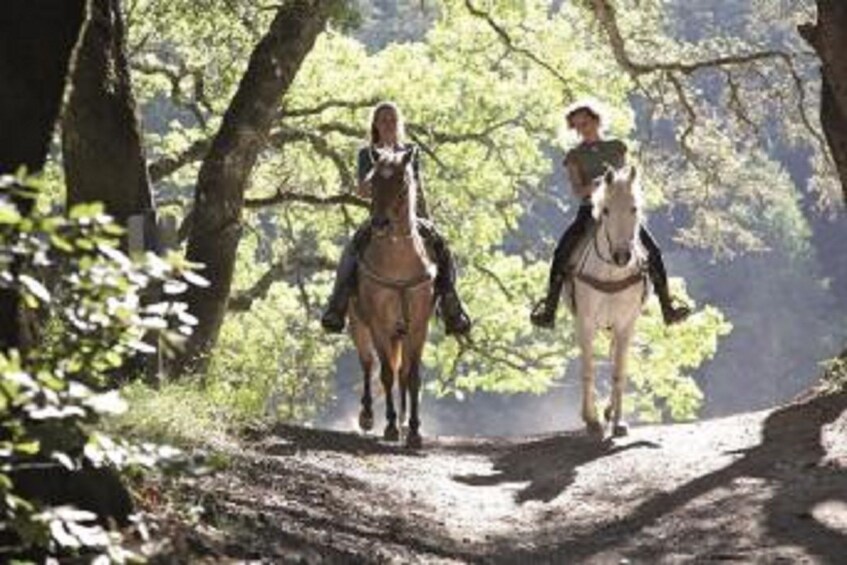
[0,0,87,351]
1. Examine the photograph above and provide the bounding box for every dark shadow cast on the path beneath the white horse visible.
[452,434,659,504]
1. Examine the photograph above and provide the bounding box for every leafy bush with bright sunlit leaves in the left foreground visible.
[0,177,196,561]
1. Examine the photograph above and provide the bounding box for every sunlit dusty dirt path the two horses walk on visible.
[154,395,847,564]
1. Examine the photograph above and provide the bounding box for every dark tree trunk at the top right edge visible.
[799,0,847,201]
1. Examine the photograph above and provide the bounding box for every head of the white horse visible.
[591,167,642,267]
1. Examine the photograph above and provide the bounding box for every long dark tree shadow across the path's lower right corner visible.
[496,393,847,563]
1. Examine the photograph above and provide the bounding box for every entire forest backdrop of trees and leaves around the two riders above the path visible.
[0,0,847,555]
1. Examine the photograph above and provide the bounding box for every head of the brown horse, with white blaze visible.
[369,149,416,235]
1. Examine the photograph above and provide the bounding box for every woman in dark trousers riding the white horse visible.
[530,102,691,328]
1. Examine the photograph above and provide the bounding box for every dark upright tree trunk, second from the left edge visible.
[62,0,153,227]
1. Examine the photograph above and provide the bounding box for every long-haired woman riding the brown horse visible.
[321,102,471,335]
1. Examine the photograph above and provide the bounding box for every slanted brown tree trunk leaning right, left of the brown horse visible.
[175,0,340,374]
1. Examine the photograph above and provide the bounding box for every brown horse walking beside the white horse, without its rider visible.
[348,151,435,448]
